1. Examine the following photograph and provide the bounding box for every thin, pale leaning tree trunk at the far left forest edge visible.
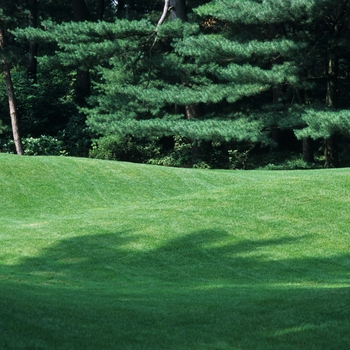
[0,22,23,155]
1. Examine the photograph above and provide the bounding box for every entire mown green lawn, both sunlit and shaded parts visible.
[0,154,350,350]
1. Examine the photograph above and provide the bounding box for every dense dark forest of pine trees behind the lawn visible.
[0,0,350,169]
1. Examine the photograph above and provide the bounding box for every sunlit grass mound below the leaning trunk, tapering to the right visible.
[0,154,239,213]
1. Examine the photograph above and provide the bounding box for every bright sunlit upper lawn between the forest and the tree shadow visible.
[0,155,350,270]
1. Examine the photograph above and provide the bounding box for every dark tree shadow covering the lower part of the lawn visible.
[0,230,350,349]
